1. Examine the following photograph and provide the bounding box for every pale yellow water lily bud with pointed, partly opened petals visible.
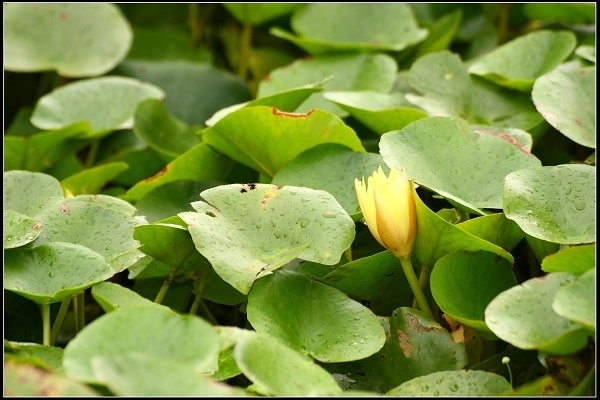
[354,167,417,258]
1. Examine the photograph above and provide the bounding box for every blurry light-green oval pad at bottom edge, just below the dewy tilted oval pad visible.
[234,333,342,396]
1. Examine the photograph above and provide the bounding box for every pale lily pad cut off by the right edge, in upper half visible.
[531,67,596,149]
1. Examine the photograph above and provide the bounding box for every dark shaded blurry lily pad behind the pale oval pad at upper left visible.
[116,60,251,126]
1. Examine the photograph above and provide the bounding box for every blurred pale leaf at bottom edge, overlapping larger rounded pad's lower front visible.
[92,353,246,397]
